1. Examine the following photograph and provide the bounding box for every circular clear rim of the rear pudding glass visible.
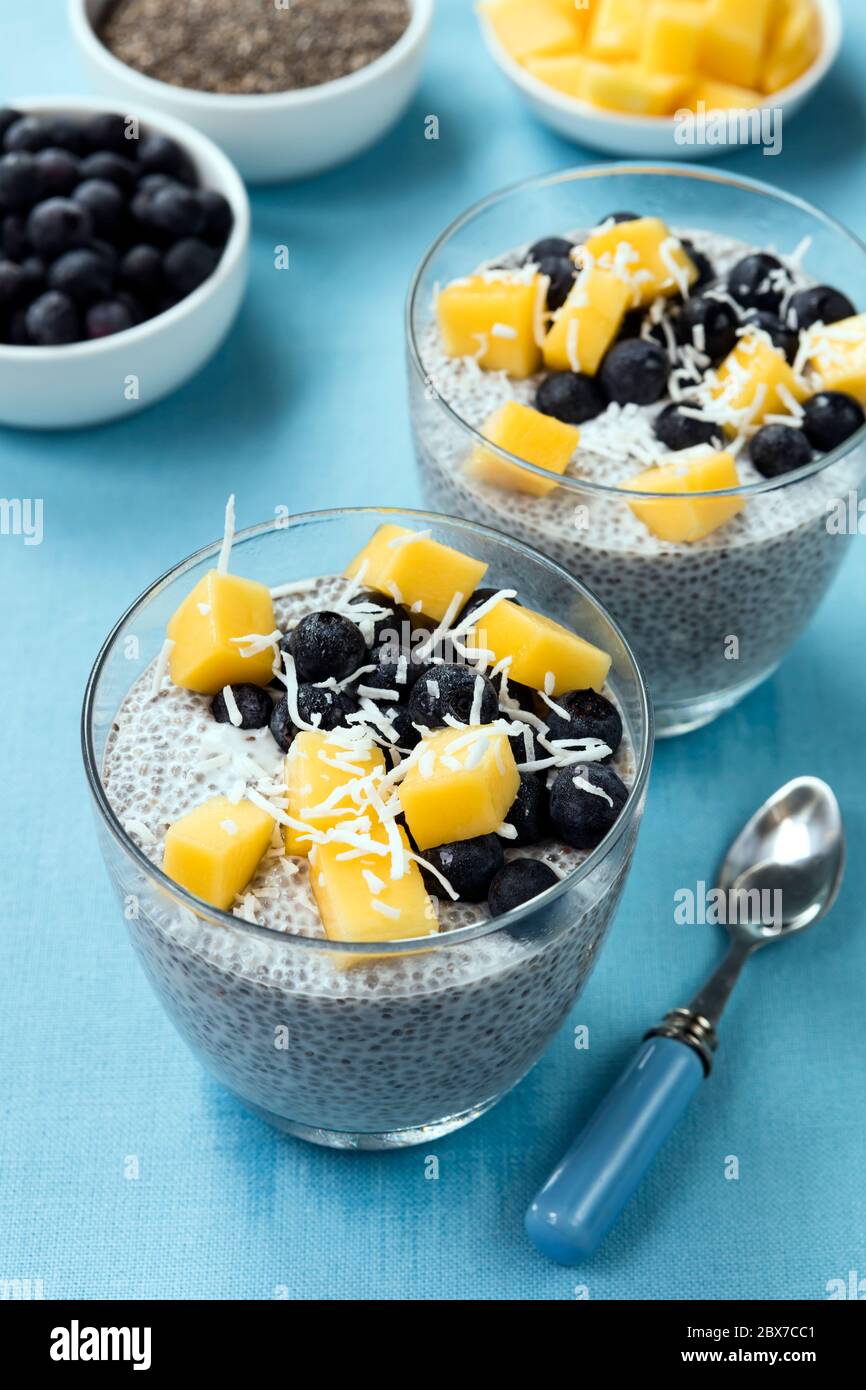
[405,161,866,502]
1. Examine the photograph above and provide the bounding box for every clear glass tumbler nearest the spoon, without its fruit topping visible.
[82,509,652,1148]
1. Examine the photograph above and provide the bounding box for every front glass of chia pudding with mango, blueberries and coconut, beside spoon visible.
[82,503,653,1148]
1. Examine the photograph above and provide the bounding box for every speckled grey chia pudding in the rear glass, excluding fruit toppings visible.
[410,214,866,733]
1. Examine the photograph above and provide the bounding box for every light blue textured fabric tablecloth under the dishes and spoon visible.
[0,0,866,1300]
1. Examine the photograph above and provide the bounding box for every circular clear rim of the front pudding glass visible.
[81,506,655,955]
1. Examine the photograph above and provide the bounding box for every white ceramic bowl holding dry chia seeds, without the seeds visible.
[70,0,434,183]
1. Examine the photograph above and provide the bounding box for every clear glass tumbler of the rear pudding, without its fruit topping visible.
[406,164,866,735]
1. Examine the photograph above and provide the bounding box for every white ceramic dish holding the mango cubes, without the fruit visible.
[480,0,842,160]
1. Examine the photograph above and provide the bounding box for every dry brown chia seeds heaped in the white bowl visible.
[97,0,410,96]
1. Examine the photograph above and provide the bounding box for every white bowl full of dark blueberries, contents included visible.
[0,97,250,430]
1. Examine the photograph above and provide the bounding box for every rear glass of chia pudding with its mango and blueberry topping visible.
[406,164,866,735]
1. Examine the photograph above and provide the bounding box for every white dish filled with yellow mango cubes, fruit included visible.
[478,0,842,158]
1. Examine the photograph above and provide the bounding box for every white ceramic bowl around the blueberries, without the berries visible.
[0,97,250,430]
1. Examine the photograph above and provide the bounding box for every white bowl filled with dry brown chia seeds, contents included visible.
[70,0,432,183]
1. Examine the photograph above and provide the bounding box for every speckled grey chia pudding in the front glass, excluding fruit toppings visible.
[94,517,642,1147]
